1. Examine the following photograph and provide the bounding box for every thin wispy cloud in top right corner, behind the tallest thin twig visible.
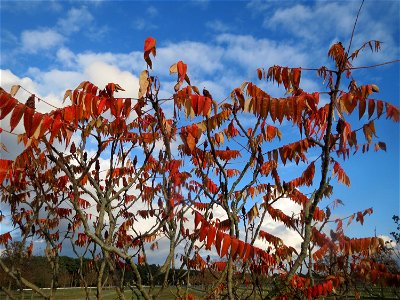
[263,1,399,64]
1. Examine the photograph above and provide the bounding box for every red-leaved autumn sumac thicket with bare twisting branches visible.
[0,32,400,299]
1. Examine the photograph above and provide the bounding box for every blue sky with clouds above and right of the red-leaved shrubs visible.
[0,0,400,251]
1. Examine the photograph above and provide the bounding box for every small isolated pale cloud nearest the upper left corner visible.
[21,29,64,53]
